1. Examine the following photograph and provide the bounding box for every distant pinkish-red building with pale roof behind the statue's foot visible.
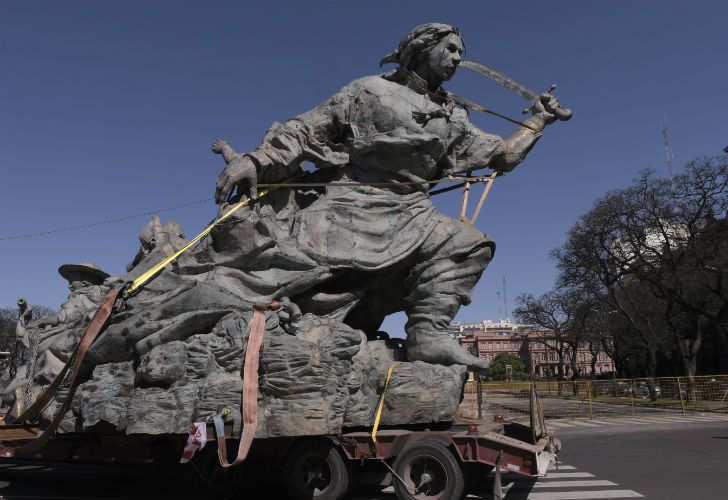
[450,320,614,378]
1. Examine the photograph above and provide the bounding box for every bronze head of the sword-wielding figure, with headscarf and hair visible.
[380,23,465,81]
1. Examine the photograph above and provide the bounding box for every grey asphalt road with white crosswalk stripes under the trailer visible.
[0,417,728,500]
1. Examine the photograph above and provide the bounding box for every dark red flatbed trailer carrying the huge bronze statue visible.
[0,388,560,500]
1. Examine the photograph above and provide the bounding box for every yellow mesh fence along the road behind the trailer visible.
[460,375,728,420]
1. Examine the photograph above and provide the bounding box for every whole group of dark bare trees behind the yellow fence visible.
[515,155,728,377]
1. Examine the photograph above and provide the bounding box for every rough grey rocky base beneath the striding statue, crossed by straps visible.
[3,270,467,437]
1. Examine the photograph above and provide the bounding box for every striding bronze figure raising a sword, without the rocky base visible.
[201,23,559,368]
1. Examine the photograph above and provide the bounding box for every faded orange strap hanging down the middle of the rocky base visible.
[213,307,265,468]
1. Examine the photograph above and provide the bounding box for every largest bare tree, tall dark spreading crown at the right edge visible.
[553,157,728,378]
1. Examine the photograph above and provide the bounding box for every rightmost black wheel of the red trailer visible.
[394,441,465,500]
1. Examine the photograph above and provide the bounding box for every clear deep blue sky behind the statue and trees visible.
[0,0,728,333]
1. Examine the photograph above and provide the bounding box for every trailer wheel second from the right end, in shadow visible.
[283,439,350,500]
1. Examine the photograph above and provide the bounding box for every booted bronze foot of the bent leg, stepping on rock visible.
[405,333,489,370]
